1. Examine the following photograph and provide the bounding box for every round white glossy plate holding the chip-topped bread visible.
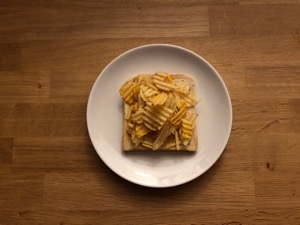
[87,44,232,187]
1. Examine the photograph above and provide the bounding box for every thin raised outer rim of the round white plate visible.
[86,43,233,188]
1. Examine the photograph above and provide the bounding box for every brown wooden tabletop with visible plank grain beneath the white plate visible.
[0,0,300,225]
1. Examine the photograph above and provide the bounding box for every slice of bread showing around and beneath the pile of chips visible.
[121,74,198,152]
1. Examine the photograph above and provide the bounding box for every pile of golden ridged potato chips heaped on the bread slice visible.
[119,72,199,150]
